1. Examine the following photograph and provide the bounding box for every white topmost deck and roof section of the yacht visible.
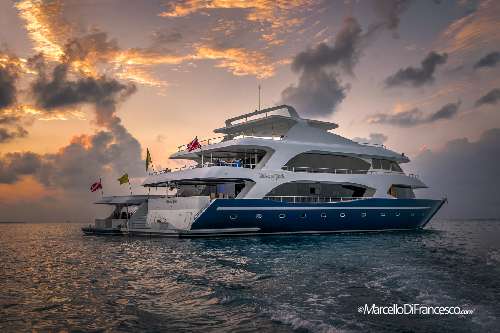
[170,105,409,163]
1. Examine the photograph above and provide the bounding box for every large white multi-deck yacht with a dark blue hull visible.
[82,105,446,237]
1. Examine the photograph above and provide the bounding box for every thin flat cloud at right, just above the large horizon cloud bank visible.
[369,102,461,127]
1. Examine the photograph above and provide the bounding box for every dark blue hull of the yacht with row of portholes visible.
[187,198,445,236]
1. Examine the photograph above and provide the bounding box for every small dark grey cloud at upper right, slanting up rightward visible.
[385,52,448,88]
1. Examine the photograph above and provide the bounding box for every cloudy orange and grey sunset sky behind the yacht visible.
[0,0,500,222]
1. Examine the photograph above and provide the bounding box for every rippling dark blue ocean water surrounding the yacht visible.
[0,220,500,332]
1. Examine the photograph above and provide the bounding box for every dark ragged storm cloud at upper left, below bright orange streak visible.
[31,64,136,126]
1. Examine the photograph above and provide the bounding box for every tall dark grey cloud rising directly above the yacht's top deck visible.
[281,17,365,116]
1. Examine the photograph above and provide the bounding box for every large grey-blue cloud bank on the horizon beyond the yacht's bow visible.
[410,128,500,218]
